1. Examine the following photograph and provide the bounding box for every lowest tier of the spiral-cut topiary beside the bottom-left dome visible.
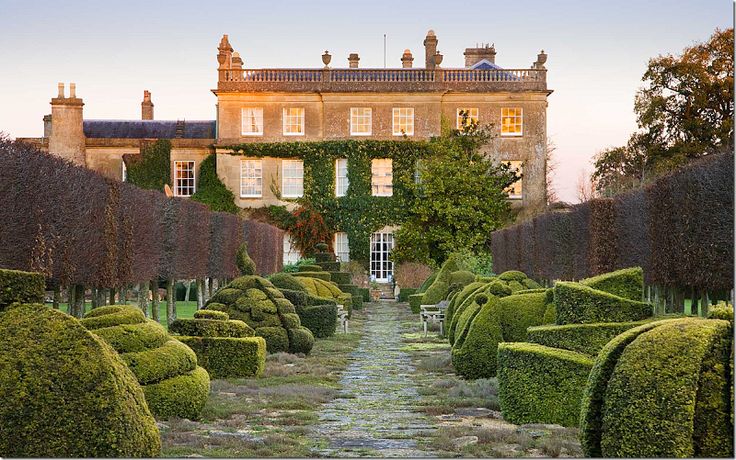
[143,366,210,420]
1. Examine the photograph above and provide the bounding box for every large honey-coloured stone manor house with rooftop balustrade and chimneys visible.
[24,30,552,281]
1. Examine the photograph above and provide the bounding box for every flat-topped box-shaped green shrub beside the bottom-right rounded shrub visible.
[498,342,593,426]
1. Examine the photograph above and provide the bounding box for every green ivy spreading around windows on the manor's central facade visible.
[228,139,429,262]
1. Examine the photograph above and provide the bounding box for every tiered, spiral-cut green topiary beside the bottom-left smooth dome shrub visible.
[81,305,210,419]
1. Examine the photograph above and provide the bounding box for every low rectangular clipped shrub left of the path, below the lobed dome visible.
[178,337,266,379]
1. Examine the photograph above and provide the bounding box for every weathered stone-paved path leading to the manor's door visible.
[316,302,437,457]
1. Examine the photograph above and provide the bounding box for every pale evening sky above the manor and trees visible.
[0,0,733,201]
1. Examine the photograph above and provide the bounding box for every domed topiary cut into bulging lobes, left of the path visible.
[207,275,314,354]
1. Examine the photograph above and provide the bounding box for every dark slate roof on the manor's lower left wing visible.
[84,120,215,139]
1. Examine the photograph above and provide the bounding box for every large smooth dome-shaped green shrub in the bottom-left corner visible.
[0,304,161,458]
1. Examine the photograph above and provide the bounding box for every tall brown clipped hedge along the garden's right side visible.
[491,153,734,290]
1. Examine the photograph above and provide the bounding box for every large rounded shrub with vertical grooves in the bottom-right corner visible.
[581,318,733,457]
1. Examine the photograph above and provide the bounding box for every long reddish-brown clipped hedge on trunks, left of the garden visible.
[0,140,283,288]
